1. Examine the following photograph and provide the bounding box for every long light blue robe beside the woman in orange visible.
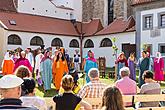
[40,58,52,90]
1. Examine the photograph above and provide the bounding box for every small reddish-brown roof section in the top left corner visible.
[0,0,17,12]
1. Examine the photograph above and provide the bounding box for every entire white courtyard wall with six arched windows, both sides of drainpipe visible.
[1,31,135,67]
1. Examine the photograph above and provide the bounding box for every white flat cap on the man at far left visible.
[0,75,23,89]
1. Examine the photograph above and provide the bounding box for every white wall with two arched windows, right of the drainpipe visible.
[83,32,135,67]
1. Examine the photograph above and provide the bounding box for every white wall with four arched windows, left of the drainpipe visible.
[5,31,79,57]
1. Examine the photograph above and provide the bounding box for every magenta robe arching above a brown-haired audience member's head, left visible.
[14,58,33,72]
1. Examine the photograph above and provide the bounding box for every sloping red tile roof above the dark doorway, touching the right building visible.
[96,16,135,35]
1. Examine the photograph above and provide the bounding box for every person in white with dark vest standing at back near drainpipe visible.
[74,50,81,71]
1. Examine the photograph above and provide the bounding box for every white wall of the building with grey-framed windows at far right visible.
[141,8,165,56]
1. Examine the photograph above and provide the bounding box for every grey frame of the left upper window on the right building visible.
[143,14,153,30]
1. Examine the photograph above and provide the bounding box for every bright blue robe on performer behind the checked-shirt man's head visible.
[84,59,98,83]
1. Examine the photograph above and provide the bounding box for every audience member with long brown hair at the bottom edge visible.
[101,87,125,110]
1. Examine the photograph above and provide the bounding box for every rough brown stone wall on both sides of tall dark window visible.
[82,0,133,24]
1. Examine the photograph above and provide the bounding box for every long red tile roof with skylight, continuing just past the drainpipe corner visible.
[0,12,103,36]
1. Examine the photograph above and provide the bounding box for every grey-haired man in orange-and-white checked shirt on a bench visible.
[78,68,106,109]
